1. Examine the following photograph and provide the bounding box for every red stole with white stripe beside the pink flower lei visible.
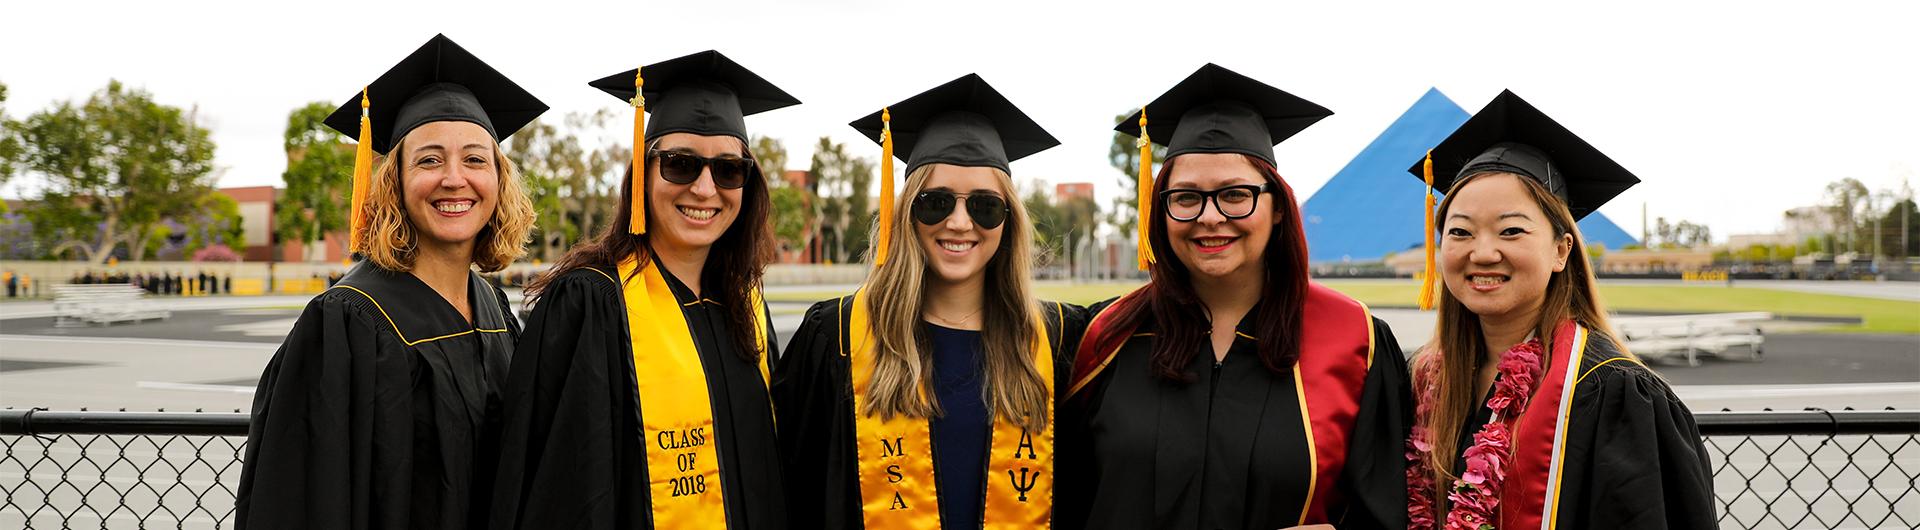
[1500,321,1632,528]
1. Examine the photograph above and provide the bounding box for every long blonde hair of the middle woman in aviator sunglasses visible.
[860,165,1052,432]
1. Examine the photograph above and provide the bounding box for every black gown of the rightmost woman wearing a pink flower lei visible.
[1434,334,1718,530]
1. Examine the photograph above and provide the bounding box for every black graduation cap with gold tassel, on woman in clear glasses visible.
[1114,63,1332,271]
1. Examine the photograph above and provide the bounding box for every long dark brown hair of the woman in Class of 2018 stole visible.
[526,140,774,363]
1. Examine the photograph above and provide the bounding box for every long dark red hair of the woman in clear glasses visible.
[1081,156,1308,382]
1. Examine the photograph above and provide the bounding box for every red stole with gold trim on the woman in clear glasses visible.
[1068,282,1375,524]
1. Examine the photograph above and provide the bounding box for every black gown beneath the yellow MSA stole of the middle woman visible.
[774,296,1087,528]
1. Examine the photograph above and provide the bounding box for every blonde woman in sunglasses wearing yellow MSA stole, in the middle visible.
[774,75,1085,528]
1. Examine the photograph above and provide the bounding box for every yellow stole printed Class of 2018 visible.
[618,257,766,528]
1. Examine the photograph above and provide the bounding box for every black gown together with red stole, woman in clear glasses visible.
[1056,284,1413,528]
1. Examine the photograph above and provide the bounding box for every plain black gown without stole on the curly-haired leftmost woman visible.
[236,261,520,530]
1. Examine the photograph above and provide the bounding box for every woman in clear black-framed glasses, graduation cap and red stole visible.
[1054,65,1411,528]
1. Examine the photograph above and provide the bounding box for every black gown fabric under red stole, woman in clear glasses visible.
[1054,300,1413,530]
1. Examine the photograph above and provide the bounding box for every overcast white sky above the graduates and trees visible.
[0,0,1920,240]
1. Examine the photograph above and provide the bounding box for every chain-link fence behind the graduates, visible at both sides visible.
[0,411,1920,528]
